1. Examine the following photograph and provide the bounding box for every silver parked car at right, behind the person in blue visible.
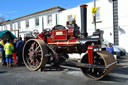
[103,40,126,58]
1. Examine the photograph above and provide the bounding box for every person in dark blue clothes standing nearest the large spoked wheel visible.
[16,37,24,66]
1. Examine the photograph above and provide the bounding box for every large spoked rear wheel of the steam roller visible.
[23,39,48,71]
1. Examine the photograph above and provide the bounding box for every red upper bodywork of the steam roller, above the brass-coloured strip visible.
[36,28,79,45]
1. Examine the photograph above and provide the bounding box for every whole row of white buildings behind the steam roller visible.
[0,0,128,52]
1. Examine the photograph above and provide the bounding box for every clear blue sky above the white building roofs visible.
[0,0,93,20]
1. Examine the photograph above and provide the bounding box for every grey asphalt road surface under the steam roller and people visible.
[0,56,128,85]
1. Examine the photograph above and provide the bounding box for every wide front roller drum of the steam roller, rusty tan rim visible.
[81,51,116,80]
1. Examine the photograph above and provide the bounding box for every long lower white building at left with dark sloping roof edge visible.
[0,6,65,37]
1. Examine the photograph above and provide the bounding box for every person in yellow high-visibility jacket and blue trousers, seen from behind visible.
[4,40,14,67]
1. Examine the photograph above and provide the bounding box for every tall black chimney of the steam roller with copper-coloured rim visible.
[80,5,88,38]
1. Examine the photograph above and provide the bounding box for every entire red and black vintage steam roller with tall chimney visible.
[23,5,116,80]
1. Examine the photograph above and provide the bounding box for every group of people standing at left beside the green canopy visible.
[0,37,25,67]
